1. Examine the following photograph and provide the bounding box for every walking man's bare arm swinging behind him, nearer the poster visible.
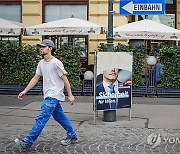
[61,74,75,105]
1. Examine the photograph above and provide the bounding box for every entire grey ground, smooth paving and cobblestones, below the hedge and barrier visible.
[0,95,180,154]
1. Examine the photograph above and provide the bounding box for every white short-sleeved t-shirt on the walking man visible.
[36,57,67,101]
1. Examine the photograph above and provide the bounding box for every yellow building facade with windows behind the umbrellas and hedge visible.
[0,0,180,67]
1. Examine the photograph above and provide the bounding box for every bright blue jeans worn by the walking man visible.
[24,97,76,145]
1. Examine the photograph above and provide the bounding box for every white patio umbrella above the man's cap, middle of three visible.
[26,18,102,35]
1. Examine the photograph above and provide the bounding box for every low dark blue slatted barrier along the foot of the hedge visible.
[0,80,180,98]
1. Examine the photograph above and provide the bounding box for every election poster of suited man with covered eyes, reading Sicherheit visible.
[95,52,133,111]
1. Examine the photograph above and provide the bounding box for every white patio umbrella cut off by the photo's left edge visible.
[0,18,25,36]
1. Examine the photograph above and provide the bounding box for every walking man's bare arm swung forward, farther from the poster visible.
[18,74,40,99]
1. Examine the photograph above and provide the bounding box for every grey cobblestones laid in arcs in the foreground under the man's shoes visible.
[0,122,180,154]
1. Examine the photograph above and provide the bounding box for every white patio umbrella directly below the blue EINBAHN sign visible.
[113,19,180,40]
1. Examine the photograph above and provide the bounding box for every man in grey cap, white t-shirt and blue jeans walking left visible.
[15,39,78,151]
